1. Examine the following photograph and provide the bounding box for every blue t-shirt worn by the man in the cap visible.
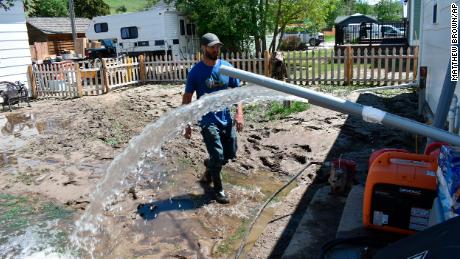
[185,59,240,127]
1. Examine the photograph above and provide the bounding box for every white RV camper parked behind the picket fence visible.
[86,3,199,59]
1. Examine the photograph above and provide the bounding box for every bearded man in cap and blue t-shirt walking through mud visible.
[182,33,244,204]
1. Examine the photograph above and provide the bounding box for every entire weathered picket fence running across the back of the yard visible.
[30,47,418,97]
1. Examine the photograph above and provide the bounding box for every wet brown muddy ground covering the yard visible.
[0,85,420,258]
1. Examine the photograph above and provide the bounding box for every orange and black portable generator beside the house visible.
[363,151,438,237]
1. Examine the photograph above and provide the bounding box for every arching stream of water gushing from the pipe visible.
[2,86,305,257]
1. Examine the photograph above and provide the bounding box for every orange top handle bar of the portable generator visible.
[372,151,438,170]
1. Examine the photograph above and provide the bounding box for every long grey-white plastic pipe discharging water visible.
[220,66,460,146]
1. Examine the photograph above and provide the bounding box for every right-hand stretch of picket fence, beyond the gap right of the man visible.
[285,47,418,85]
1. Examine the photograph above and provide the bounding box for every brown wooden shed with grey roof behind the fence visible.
[27,17,91,55]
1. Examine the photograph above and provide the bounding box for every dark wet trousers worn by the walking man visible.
[201,124,237,192]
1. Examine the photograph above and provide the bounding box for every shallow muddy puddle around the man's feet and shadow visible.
[124,166,296,257]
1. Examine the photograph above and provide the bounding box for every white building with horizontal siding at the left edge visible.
[0,0,32,85]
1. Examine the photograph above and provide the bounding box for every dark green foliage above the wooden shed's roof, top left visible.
[28,0,68,17]
